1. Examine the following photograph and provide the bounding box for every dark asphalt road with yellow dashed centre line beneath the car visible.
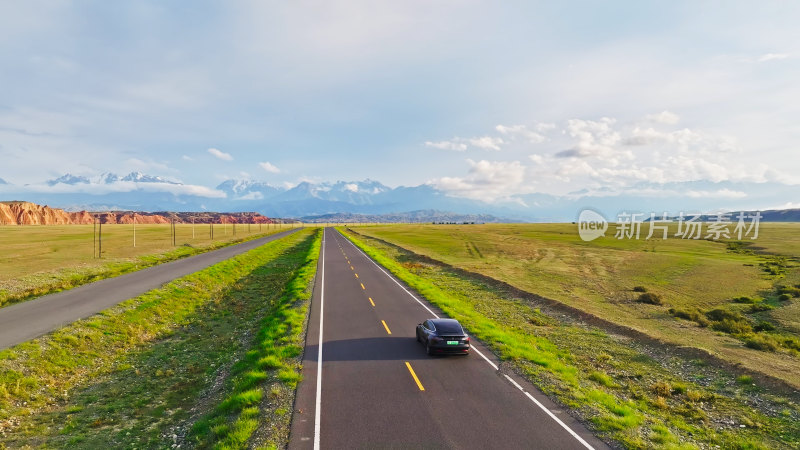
[289,229,608,449]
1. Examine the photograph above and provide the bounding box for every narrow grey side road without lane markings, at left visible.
[0,228,299,349]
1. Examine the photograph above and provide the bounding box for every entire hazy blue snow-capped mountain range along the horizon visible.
[0,172,800,221]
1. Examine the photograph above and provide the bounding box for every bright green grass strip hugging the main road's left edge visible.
[191,233,322,449]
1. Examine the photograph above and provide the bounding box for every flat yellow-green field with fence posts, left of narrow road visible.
[0,224,291,306]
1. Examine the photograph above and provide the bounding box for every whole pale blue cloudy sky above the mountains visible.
[0,0,800,206]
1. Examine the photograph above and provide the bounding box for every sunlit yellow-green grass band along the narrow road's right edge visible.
[0,230,312,448]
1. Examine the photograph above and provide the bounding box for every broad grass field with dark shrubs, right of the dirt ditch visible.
[355,223,800,387]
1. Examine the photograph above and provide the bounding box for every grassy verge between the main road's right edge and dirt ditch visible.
[345,232,800,449]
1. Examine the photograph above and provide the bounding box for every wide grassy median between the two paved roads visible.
[0,229,320,448]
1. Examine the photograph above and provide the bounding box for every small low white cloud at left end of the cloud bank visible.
[430,159,525,202]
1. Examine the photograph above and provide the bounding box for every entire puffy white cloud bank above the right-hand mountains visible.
[422,110,800,201]
